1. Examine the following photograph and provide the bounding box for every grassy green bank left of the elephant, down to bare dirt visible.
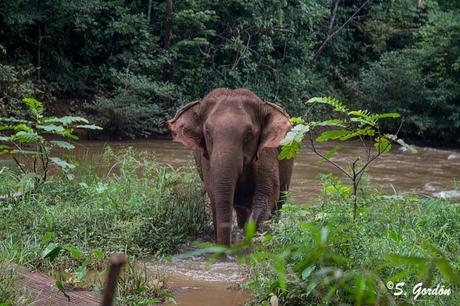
[0,149,210,305]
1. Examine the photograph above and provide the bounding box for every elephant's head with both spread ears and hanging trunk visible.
[169,89,291,243]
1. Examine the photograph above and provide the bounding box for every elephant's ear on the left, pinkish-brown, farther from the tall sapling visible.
[168,101,204,150]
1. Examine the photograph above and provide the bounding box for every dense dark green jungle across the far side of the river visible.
[0,0,460,145]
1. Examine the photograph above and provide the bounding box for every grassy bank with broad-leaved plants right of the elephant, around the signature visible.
[244,185,460,305]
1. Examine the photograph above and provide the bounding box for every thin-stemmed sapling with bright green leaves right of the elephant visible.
[279,97,416,216]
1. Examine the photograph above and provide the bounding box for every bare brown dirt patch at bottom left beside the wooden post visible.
[15,266,101,306]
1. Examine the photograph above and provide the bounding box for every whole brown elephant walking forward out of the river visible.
[168,88,293,245]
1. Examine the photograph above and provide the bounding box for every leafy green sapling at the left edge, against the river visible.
[0,98,101,183]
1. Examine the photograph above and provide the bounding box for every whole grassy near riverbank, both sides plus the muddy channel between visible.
[0,148,460,305]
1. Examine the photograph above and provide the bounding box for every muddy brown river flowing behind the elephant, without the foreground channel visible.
[73,140,460,204]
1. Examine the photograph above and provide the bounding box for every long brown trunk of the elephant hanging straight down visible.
[211,149,243,245]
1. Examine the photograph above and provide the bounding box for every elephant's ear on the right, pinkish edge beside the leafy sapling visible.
[259,102,292,150]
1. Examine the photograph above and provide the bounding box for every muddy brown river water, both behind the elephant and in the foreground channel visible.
[65,140,460,306]
